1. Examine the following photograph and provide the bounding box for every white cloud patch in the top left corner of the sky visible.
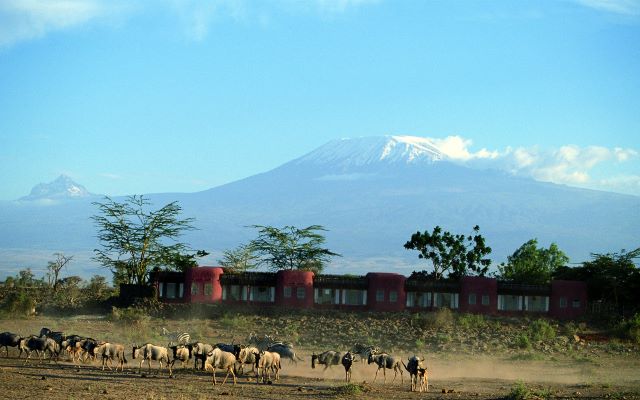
[0,0,120,47]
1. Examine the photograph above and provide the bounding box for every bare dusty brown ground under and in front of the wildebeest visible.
[0,319,640,400]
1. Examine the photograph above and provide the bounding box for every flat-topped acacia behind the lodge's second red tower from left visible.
[249,225,340,273]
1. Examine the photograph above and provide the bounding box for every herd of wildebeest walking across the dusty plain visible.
[0,328,429,392]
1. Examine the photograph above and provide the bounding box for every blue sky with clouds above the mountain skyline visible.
[0,0,640,200]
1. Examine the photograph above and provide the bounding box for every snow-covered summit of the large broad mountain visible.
[295,136,443,168]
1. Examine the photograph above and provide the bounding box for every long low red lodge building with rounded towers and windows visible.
[151,267,587,319]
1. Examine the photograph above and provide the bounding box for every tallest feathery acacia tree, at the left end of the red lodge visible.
[92,195,194,284]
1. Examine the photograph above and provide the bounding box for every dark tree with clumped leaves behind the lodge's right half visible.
[404,225,491,279]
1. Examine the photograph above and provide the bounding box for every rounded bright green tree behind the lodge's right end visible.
[498,239,569,284]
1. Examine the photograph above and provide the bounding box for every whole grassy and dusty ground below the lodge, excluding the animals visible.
[0,307,640,400]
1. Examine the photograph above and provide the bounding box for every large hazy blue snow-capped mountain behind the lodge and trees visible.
[0,136,640,274]
